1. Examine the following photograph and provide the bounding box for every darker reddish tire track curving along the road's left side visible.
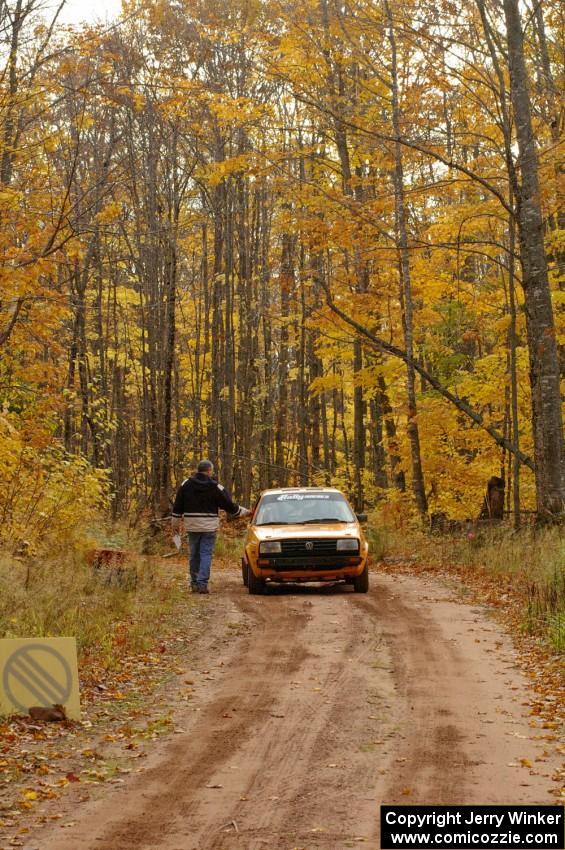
[41,592,305,850]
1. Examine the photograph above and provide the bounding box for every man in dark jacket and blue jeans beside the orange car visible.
[172,460,251,593]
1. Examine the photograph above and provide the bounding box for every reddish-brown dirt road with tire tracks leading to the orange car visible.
[34,573,558,850]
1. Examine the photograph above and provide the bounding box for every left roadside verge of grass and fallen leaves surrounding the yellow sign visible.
[0,535,214,846]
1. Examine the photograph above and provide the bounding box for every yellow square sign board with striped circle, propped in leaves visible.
[0,638,80,720]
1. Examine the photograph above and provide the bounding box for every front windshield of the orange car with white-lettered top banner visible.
[255,492,355,525]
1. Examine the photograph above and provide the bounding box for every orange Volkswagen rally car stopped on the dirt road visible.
[241,487,369,593]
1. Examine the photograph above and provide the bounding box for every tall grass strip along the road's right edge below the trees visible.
[387,526,565,653]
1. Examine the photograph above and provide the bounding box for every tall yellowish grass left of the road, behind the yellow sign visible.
[0,528,189,670]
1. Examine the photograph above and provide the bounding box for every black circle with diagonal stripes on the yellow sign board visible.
[2,643,73,712]
